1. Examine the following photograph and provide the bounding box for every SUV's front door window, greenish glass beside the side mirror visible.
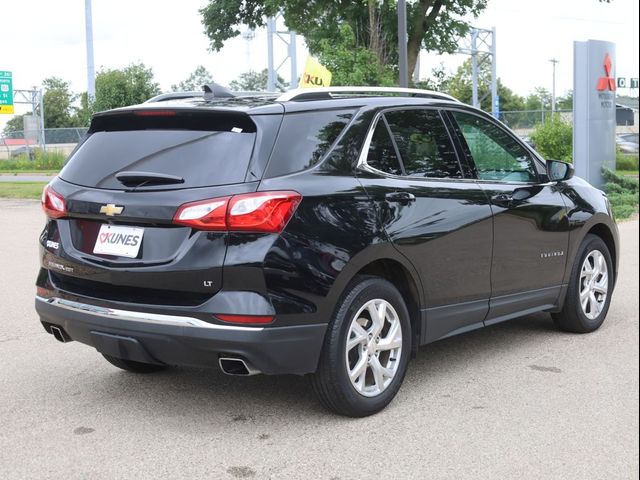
[451,111,538,183]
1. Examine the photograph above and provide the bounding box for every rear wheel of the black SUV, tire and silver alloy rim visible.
[311,276,411,417]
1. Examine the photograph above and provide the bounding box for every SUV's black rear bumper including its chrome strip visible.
[36,297,327,375]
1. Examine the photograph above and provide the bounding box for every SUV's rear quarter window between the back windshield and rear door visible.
[265,110,354,178]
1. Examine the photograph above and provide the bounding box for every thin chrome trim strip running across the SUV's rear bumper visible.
[36,296,264,332]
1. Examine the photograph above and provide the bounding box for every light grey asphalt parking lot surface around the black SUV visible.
[0,200,638,479]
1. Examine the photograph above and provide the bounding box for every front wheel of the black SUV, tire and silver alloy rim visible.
[552,234,615,333]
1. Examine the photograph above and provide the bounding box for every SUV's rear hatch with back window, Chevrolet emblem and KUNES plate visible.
[43,108,280,306]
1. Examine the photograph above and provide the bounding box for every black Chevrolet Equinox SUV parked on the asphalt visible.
[36,87,619,416]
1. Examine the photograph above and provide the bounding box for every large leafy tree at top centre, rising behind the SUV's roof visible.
[200,0,487,79]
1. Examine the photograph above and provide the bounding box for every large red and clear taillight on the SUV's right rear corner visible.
[173,191,302,233]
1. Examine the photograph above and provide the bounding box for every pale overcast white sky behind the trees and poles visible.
[0,0,640,130]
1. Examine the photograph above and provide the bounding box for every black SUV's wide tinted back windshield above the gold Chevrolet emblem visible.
[60,112,256,189]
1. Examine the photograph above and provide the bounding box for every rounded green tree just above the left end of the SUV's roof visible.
[94,63,160,112]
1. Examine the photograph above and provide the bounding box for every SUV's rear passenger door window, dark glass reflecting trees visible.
[384,109,462,178]
